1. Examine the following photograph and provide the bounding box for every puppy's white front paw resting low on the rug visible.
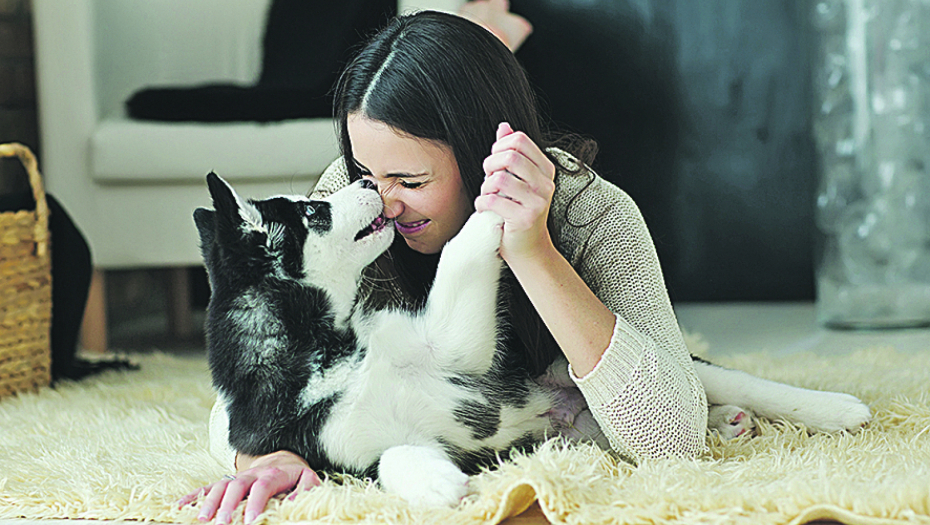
[378,445,468,507]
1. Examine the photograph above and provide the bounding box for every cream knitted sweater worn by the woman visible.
[210,150,707,464]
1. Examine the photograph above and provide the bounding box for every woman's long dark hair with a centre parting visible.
[335,11,588,374]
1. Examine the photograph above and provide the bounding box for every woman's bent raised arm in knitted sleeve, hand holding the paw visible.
[475,124,707,460]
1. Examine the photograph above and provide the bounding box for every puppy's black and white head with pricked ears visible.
[194,173,394,288]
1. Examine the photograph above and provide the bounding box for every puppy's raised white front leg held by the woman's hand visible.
[418,212,503,374]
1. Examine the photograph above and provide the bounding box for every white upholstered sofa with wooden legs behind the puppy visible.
[33,0,461,348]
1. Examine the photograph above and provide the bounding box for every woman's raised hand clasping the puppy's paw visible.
[475,122,555,265]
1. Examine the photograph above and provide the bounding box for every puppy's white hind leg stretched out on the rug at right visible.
[694,361,871,432]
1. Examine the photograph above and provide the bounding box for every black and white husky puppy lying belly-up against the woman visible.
[194,173,554,504]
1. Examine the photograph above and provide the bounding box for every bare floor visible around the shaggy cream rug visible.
[0,303,930,525]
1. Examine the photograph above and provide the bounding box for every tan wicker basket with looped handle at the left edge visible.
[0,144,52,398]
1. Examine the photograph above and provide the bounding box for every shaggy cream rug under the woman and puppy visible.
[0,342,930,525]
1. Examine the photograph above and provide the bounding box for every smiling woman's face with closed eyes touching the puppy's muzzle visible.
[347,113,474,253]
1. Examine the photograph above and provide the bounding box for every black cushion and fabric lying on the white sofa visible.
[126,0,397,122]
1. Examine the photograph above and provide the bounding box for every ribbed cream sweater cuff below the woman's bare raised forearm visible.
[568,314,648,407]
